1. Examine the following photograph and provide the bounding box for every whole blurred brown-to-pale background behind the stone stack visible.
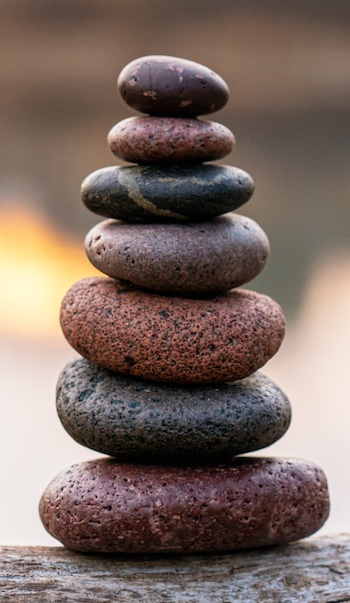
[0,0,350,545]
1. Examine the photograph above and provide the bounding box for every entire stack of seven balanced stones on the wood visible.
[40,56,329,553]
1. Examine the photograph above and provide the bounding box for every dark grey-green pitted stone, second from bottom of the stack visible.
[57,358,291,462]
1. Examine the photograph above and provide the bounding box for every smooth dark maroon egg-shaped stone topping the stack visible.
[118,55,229,117]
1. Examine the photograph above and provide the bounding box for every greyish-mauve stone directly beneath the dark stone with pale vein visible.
[85,213,270,294]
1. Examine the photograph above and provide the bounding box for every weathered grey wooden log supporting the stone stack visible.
[0,534,350,603]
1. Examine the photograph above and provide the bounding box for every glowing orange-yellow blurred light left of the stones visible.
[0,204,96,337]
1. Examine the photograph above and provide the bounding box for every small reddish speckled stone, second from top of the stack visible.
[107,117,235,163]
